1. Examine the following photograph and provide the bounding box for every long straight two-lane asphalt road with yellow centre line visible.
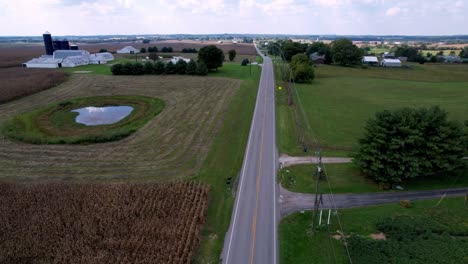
[222,48,279,264]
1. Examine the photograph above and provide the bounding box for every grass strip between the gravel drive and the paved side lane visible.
[278,163,468,193]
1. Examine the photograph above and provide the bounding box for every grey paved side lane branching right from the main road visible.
[280,186,468,217]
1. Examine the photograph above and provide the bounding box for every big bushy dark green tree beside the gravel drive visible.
[354,106,467,183]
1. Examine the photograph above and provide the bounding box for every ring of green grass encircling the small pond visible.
[2,96,164,144]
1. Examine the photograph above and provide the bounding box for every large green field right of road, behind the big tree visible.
[277,64,468,156]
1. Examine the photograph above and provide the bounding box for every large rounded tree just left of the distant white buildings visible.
[331,38,363,66]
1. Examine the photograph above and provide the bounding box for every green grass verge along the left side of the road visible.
[194,63,261,263]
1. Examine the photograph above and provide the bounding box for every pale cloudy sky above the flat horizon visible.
[0,0,468,36]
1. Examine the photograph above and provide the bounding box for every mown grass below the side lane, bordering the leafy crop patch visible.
[279,197,468,264]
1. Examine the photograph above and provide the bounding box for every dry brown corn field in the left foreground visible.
[0,182,208,264]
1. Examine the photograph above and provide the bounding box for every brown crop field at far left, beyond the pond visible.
[0,67,67,103]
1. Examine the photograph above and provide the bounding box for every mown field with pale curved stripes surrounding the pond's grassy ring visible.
[0,75,241,181]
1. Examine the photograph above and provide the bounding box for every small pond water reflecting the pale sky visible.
[72,106,133,126]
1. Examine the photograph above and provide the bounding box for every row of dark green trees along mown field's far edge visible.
[111,60,208,76]
